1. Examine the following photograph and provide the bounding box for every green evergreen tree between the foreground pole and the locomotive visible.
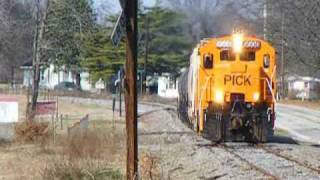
[139,6,192,74]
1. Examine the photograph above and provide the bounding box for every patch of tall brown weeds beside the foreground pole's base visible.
[41,122,125,180]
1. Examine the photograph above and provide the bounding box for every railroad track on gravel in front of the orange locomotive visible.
[216,143,320,180]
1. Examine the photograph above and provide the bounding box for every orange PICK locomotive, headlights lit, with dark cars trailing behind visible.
[178,34,276,142]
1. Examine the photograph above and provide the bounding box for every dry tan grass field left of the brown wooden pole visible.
[0,96,125,179]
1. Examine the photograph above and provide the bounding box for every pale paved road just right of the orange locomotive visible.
[275,104,320,144]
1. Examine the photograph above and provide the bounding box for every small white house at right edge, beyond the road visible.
[288,76,320,99]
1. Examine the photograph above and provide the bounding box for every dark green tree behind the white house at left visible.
[47,0,95,88]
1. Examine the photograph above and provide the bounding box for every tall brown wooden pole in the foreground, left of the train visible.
[124,0,138,180]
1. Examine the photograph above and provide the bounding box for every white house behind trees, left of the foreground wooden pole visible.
[20,62,101,91]
